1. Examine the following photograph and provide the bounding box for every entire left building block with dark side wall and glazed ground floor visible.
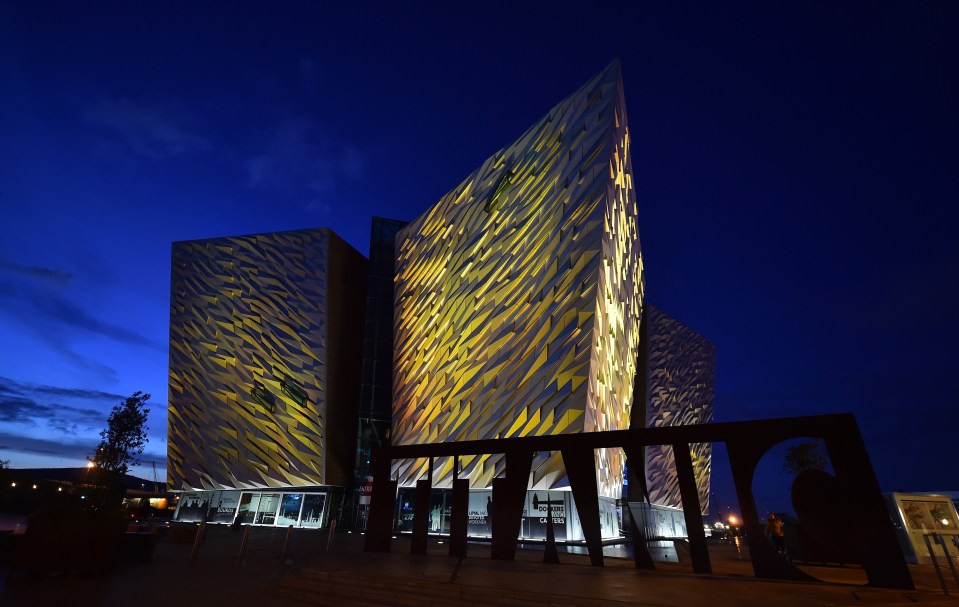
[167,228,366,524]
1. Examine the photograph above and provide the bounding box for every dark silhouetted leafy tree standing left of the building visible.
[89,392,150,475]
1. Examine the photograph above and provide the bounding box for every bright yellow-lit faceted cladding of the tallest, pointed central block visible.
[392,63,643,497]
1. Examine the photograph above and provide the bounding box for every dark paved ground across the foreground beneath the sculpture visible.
[0,526,959,607]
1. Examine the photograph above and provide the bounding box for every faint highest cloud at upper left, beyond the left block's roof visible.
[82,97,213,160]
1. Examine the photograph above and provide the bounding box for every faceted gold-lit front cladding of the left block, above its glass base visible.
[167,228,330,490]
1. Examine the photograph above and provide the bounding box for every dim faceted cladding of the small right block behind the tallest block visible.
[643,306,716,513]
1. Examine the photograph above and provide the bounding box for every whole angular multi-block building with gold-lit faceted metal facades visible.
[168,62,715,540]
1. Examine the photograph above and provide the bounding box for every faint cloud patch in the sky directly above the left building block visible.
[246,118,366,202]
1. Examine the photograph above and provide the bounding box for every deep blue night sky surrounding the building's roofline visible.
[0,0,959,508]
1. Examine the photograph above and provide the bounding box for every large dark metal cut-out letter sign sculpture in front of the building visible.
[366,414,914,589]
